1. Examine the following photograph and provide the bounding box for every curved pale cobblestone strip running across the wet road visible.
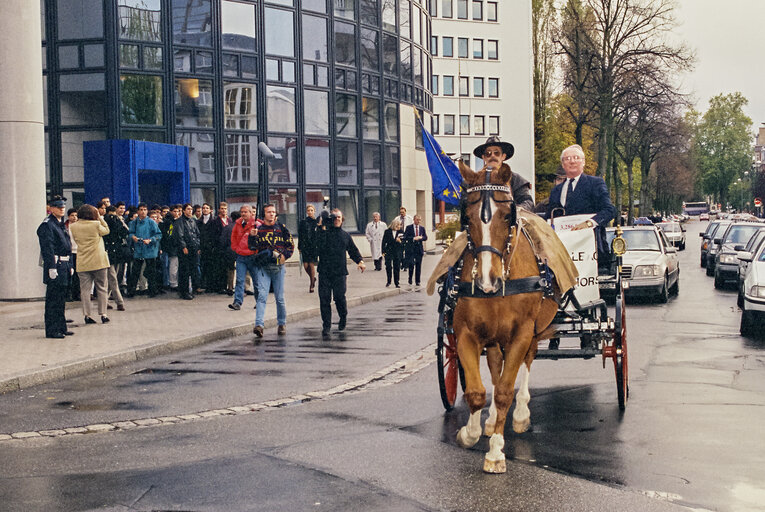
[0,343,436,442]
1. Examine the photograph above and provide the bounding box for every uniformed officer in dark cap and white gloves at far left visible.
[37,196,74,339]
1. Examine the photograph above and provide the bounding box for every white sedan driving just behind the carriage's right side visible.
[606,226,680,302]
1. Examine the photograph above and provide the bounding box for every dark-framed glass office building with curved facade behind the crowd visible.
[41,0,432,231]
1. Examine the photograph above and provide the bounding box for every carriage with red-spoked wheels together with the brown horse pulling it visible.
[428,166,629,473]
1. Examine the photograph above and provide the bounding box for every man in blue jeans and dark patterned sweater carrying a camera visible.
[247,204,295,338]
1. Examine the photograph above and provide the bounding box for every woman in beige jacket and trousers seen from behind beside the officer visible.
[70,204,109,324]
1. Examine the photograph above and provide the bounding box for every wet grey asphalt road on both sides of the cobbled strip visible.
[0,223,765,511]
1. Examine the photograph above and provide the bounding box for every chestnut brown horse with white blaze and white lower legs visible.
[453,165,558,473]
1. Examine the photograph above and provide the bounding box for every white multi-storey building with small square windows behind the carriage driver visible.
[430,0,534,190]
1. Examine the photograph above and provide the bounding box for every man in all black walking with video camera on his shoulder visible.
[316,208,366,336]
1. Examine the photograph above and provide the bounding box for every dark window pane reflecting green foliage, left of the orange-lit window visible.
[120,74,163,126]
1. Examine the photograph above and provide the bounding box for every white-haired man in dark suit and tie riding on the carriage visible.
[546,144,616,268]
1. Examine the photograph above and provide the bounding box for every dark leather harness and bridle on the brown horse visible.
[444,171,553,298]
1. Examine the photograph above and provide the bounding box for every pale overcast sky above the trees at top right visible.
[676,0,765,133]
